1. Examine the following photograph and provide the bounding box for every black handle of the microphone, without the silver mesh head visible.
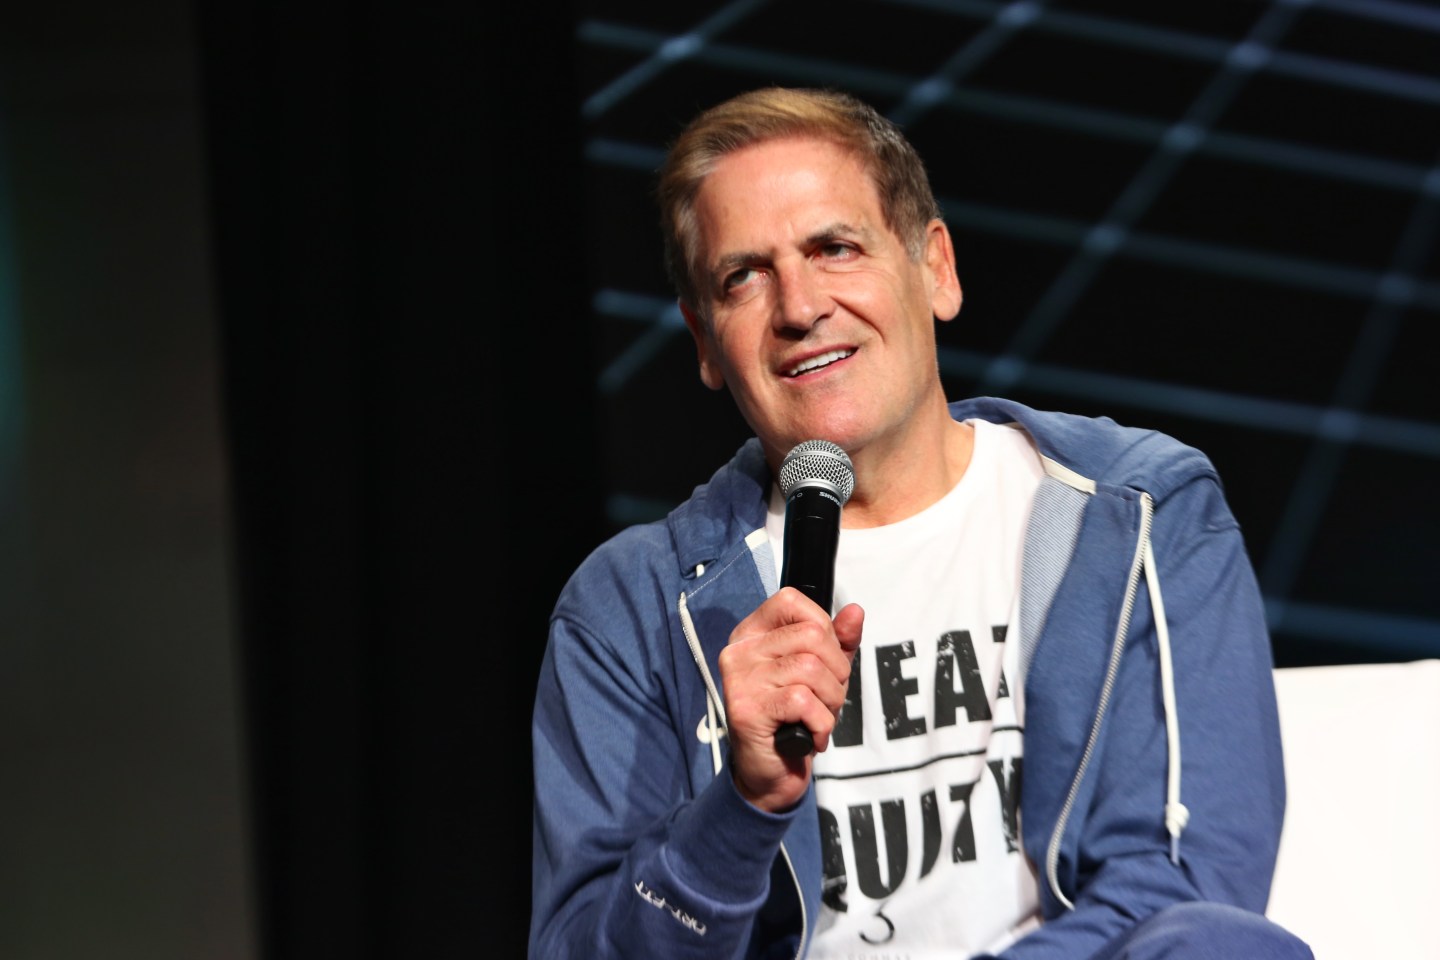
[775,486,840,759]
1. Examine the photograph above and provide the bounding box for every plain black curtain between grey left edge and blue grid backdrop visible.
[196,0,602,960]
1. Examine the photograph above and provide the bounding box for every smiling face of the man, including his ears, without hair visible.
[684,138,960,462]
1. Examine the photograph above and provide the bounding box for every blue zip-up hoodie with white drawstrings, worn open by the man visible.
[530,397,1284,960]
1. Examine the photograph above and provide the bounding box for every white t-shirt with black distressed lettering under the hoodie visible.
[766,420,1043,960]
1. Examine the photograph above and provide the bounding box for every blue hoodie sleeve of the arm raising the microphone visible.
[530,594,793,960]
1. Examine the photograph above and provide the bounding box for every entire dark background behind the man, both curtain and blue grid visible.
[0,0,1440,960]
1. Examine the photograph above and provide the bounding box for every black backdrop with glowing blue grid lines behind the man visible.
[575,0,1440,665]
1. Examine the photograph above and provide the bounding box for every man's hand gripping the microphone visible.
[720,587,865,813]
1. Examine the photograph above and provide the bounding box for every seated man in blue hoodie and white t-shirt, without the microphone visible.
[530,89,1309,960]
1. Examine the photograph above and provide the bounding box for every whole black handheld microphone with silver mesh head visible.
[775,440,855,757]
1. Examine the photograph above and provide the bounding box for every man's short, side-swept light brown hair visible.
[655,86,940,311]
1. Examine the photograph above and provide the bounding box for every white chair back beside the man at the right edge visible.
[1266,659,1440,960]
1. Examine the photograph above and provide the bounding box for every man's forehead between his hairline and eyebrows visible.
[694,138,883,256]
